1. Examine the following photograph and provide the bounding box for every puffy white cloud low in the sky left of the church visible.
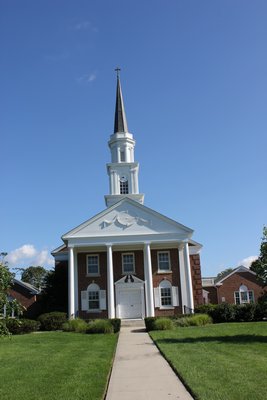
[6,244,54,268]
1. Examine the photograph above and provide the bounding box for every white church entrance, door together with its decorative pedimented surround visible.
[115,277,145,319]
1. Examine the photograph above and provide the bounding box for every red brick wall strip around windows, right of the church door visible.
[151,249,182,317]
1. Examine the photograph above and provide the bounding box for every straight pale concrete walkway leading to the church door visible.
[106,326,193,400]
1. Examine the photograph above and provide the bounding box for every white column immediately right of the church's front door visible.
[144,243,155,317]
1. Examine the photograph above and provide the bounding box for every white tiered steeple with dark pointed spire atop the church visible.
[105,68,144,207]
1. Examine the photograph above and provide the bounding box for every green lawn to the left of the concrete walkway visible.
[0,332,118,400]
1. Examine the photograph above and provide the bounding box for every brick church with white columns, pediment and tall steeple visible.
[52,74,202,319]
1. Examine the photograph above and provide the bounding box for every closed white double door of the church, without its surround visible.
[118,287,143,319]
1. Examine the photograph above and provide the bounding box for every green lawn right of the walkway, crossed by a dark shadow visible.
[151,322,267,400]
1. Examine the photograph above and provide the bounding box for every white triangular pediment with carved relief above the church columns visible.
[62,198,193,240]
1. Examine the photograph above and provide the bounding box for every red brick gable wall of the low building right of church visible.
[218,272,263,304]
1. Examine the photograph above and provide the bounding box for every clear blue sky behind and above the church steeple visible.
[0,0,267,276]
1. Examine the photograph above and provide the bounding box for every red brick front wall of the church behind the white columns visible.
[77,249,203,319]
